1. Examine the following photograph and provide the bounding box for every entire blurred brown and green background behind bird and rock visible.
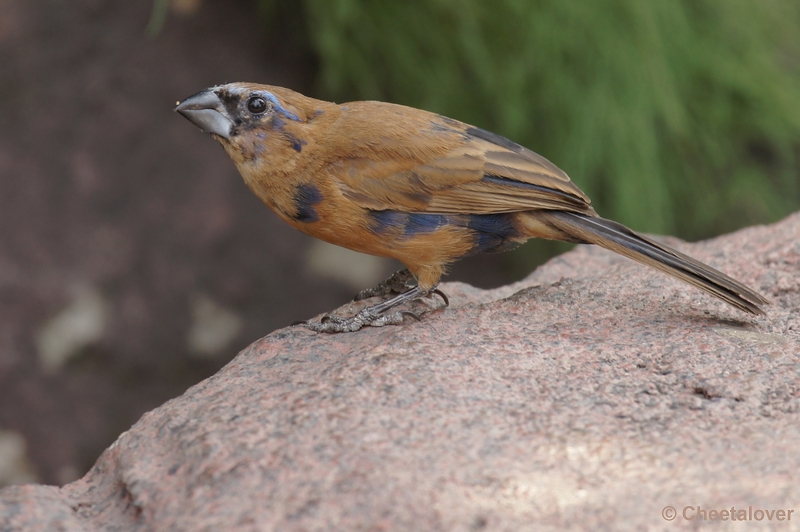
[0,0,800,486]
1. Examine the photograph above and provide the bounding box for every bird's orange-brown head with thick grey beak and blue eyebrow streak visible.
[175,83,326,170]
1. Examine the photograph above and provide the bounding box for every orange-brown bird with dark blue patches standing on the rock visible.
[175,82,769,333]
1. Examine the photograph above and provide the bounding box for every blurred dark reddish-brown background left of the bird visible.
[0,0,510,485]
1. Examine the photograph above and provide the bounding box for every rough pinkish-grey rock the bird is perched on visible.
[0,214,800,531]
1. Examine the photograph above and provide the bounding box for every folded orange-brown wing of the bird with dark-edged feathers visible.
[329,106,594,214]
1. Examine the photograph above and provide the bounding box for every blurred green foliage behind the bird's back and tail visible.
[260,0,800,239]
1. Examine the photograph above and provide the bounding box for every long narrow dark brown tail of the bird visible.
[535,211,769,314]
